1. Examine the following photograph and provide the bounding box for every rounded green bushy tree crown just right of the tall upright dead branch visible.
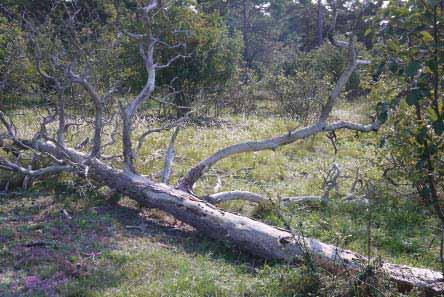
[155,7,241,114]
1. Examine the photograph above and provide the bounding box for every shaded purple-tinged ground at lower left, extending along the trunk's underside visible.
[0,194,272,296]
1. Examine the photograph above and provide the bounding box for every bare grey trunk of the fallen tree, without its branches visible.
[36,142,444,294]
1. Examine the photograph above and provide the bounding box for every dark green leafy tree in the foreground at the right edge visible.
[380,0,444,223]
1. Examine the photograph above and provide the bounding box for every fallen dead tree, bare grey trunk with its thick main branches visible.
[0,0,444,293]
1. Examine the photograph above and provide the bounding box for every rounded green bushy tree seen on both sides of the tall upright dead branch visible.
[121,1,241,115]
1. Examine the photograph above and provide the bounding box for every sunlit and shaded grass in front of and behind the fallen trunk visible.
[0,101,440,296]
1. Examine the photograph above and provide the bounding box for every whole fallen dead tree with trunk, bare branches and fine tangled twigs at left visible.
[8,0,438,293]
